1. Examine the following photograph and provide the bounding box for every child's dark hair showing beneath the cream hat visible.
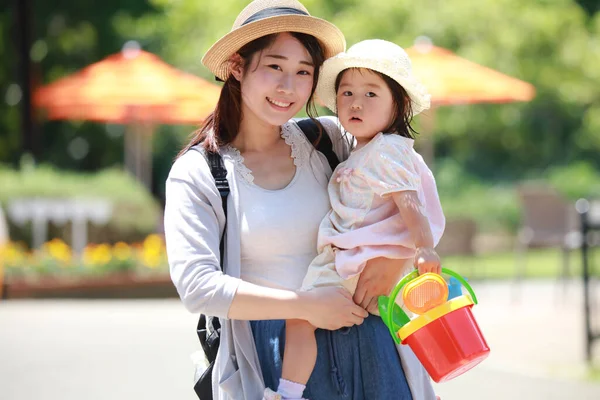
[335,68,418,139]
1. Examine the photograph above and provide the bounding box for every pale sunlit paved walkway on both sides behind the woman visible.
[0,282,600,400]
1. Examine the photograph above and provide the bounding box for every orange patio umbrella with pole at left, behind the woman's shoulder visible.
[33,48,221,185]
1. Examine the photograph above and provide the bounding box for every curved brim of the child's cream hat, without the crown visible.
[316,54,431,116]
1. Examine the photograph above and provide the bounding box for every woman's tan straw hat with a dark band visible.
[202,0,346,80]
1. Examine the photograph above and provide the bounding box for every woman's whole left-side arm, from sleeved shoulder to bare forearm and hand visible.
[165,151,366,329]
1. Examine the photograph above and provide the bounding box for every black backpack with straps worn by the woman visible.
[194,118,339,400]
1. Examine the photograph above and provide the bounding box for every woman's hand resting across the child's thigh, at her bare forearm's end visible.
[299,287,369,330]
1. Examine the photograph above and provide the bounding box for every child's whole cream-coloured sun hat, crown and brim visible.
[317,39,431,115]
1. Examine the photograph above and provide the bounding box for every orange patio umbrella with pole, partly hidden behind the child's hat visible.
[406,43,535,162]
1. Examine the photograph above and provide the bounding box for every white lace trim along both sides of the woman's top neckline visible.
[223,123,308,183]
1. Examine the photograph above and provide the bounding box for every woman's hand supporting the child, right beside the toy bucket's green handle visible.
[354,257,404,314]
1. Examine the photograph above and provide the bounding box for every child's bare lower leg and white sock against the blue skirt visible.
[277,319,317,398]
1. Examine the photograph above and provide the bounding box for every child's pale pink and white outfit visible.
[302,133,445,293]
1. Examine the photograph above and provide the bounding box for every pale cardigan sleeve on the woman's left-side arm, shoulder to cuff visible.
[164,158,240,318]
